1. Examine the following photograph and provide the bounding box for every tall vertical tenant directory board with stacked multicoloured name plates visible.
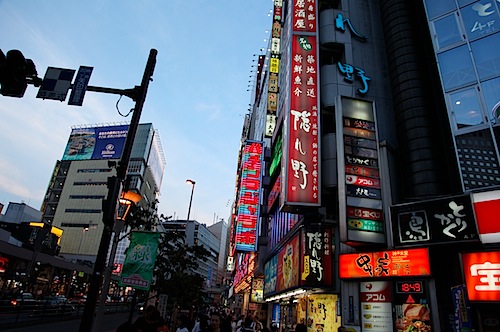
[337,96,385,243]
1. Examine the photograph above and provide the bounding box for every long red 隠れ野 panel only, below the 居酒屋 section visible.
[283,36,320,205]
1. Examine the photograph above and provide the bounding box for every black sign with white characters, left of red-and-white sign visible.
[391,195,478,245]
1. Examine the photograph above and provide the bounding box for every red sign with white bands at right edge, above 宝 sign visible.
[472,190,500,243]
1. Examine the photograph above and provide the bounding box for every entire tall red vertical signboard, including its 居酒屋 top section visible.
[282,0,321,206]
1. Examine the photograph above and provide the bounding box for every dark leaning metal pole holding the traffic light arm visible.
[79,49,158,332]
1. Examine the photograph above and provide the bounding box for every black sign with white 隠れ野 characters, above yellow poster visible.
[300,227,332,286]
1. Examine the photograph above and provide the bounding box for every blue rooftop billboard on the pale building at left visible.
[62,125,129,160]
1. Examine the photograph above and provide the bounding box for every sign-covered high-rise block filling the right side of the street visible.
[228,0,500,332]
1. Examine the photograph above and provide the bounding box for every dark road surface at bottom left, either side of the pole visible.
[2,313,138,332]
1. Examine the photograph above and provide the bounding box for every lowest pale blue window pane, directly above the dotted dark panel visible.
[450,88,483,129]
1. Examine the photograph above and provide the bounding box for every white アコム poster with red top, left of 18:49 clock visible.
[360,281,394,332]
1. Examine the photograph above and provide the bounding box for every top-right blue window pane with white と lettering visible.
[460,0,500,40]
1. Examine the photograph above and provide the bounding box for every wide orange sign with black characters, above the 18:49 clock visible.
[339,248,431,279]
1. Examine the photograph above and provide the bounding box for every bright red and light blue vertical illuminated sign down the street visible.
[235,141,264,251]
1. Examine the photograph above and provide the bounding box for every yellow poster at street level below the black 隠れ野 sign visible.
[305,294,341,332]
